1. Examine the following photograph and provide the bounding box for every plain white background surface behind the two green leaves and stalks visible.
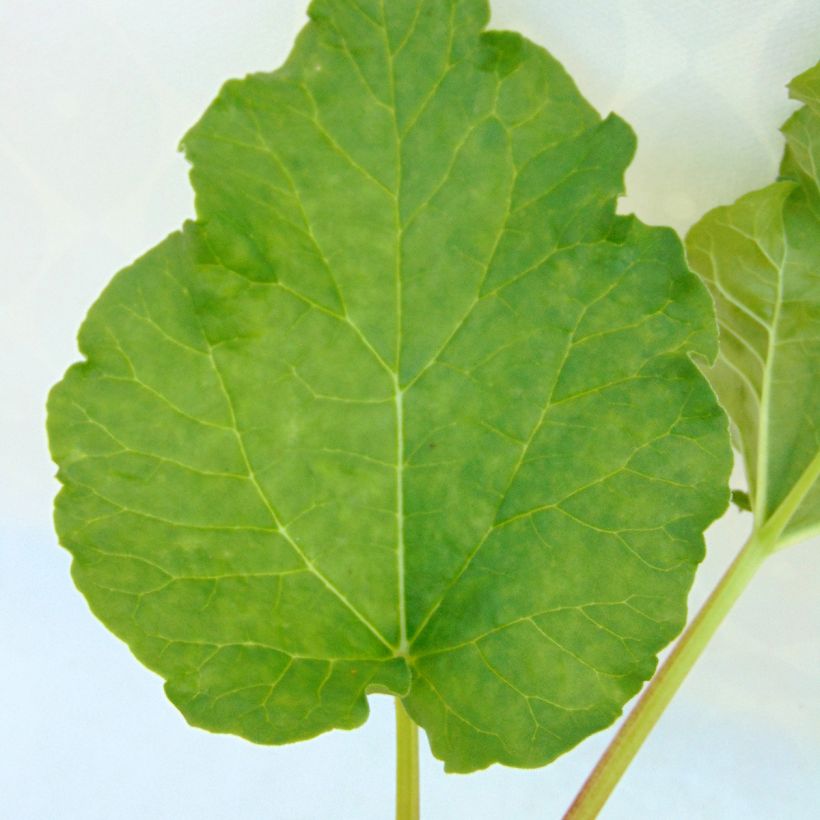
[0,0,820,820]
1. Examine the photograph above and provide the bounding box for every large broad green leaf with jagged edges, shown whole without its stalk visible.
[49,0,731,771]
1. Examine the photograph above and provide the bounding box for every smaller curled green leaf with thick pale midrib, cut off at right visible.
[687,64,820,548]
